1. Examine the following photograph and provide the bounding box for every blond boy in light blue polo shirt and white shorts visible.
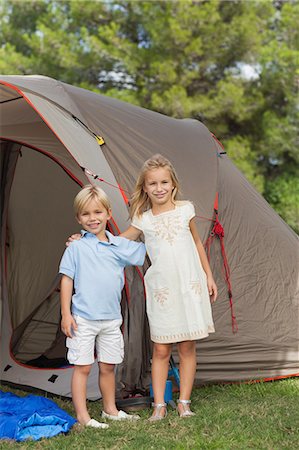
[59,185,145,428]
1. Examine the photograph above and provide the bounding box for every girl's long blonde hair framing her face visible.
[130,154,180,218]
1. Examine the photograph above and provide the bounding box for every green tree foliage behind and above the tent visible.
[0,0,299,229]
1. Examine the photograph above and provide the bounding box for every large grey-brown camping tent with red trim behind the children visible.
[0,76,299,399]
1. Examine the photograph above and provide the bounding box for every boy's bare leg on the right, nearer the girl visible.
[99,362,118,416]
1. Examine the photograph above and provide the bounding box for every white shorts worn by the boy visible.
[66,315,124,366]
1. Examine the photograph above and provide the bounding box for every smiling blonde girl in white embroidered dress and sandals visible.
[121,155,217,421]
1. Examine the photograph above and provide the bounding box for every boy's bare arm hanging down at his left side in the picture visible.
[60,275,78,338]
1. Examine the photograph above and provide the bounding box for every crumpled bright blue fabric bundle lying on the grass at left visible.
[0,391,76,441]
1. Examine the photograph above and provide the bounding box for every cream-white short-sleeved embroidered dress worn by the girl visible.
[132,201,215,344]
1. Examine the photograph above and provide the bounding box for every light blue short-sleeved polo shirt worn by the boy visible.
[59,231,146,320]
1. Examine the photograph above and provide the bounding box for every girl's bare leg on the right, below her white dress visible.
[178,341,196,413]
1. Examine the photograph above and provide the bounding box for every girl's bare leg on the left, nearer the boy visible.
[152,343,172,416]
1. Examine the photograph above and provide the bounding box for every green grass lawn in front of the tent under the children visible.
[0,378,299,450]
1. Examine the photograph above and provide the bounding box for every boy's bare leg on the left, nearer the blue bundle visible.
[72,365,91,425]
